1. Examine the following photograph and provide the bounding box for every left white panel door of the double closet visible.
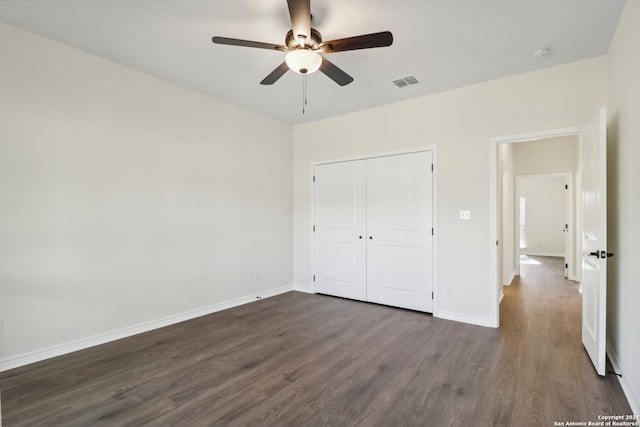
[313,160,367,301]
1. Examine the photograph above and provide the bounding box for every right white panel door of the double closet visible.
[366,152,433,312]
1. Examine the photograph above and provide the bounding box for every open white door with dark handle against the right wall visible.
[581,108,609,375]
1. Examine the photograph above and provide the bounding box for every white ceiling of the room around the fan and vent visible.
[0,0,624,124]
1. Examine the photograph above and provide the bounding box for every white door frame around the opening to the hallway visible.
[488,126,588,328]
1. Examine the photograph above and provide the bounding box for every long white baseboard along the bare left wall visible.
[0,285,292,372]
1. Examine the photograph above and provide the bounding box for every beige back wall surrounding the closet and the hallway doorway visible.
[293,57,606,324]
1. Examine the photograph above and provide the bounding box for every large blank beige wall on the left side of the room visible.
[0,24,292,365]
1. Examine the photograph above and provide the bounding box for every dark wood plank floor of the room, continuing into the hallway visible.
[0,257,631,427]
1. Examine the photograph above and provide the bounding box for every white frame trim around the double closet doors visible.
[309,144,439,317]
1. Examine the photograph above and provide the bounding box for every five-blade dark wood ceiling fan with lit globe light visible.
[212,0,393,86]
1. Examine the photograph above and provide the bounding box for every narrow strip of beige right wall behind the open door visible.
[607,0,640,416]
